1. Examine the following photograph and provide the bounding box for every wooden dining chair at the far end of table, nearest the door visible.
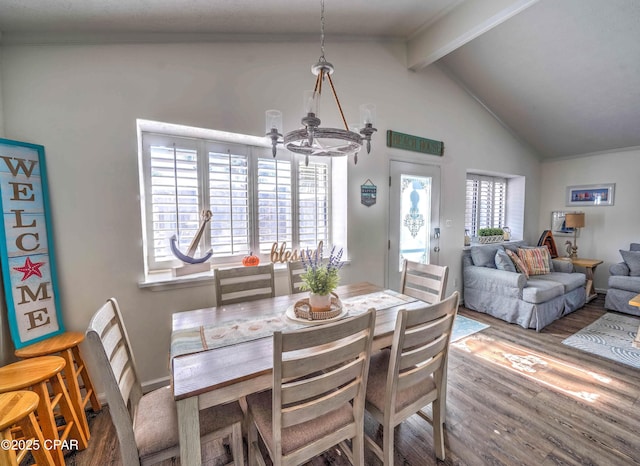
[400,259,449,304]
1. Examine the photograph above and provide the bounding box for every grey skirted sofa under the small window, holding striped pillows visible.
[462,241,586,332]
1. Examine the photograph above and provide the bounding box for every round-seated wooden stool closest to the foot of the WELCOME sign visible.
[15,332,102,440]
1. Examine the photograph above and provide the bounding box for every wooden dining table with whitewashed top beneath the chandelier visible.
[171,283,425,466]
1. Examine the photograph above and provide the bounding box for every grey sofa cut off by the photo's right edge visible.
[604,243,640,316]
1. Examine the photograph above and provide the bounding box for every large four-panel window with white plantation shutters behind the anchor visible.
[140,125,332,272]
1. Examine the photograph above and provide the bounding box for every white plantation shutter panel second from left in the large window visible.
[208,148,251,258]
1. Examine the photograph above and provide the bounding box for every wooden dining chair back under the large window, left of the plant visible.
[213,263,275,306]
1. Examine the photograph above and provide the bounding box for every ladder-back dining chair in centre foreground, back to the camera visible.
[247,309,376,466]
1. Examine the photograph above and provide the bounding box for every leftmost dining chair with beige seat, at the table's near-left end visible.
[86,298,244,466]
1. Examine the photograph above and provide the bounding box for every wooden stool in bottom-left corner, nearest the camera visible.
[0,391,54,466]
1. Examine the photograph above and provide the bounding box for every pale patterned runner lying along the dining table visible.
[171,290,417,358]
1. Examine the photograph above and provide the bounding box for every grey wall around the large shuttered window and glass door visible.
[0,37,540,381]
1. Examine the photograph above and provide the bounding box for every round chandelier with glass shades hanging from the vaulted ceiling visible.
[266,0,377,165]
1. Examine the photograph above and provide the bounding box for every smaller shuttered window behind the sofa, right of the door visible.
[464,173,507,236]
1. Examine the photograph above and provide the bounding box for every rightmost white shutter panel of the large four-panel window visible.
[298,162,329,249]
